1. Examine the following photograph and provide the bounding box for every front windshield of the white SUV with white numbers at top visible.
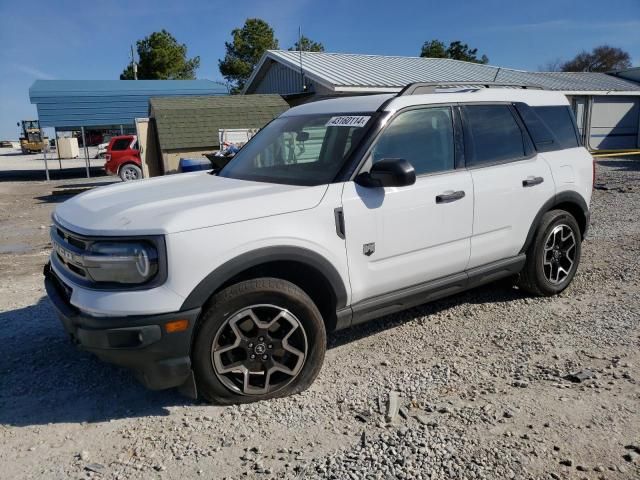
[218,113,373,186]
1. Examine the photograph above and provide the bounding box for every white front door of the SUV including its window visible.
[342,106,473,312]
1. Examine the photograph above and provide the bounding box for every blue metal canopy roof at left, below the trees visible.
[29,80,227,129]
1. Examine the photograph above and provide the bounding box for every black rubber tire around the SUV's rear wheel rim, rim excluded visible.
[518,210,582,297]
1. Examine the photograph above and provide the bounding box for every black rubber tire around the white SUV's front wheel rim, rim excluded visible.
[192,278,327,405]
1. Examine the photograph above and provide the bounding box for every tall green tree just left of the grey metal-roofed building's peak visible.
[218,18,278,93]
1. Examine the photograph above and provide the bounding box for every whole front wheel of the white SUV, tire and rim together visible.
[193,278,326,404]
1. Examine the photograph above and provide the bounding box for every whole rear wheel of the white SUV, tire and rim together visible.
[518,210,582,296]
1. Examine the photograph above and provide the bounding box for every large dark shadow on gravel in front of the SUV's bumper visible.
[0,297,192,426]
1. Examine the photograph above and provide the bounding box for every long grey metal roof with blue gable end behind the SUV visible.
[244,50,640,95]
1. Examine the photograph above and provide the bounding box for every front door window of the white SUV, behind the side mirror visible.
[371,107,455,175]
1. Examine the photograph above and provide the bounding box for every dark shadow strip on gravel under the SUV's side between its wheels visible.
[327,281,528,348]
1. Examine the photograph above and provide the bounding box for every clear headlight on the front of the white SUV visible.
[83,242,158,284]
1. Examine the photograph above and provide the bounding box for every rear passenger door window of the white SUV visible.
[464,105,525,166]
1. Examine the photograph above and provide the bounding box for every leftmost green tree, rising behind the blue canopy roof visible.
[120,30,200,80]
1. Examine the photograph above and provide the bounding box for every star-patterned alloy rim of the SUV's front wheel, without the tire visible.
[211,304,308,395]
